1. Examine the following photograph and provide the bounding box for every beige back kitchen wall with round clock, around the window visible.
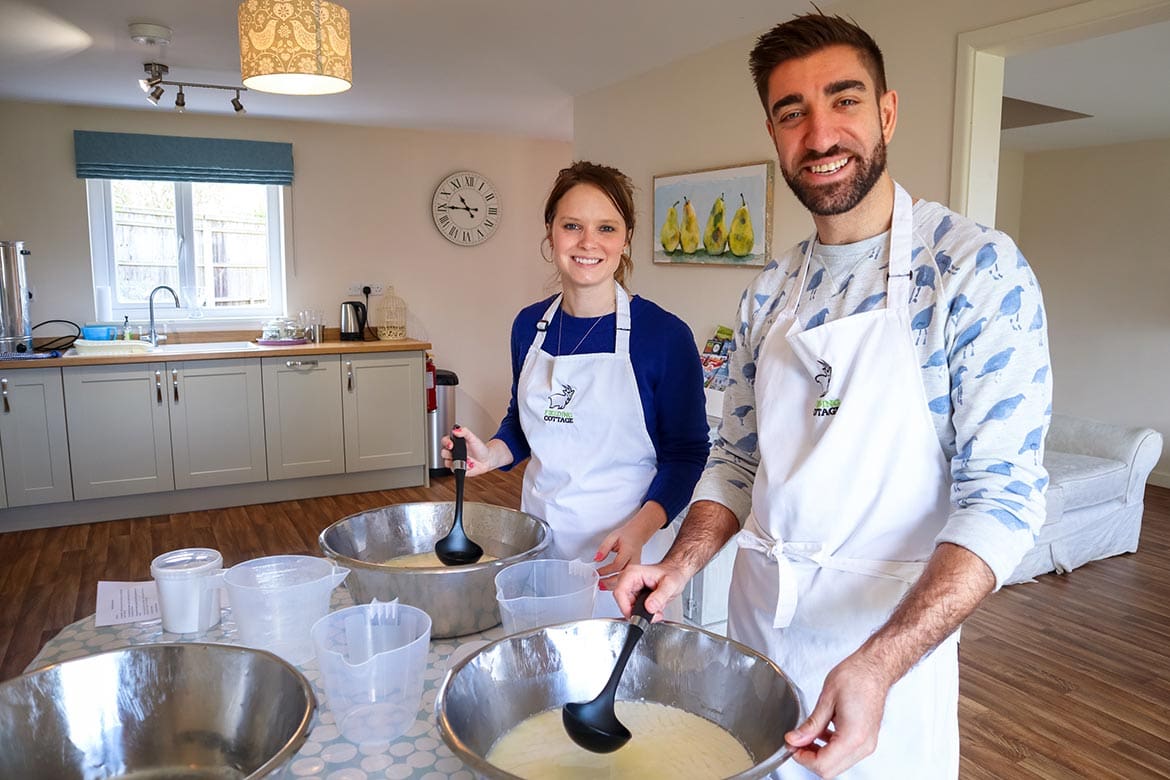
[0,98,571,434]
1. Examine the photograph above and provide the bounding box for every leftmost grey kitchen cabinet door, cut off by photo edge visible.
[0,368,73,506]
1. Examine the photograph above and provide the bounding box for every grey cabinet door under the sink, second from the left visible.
[62,363,174,499]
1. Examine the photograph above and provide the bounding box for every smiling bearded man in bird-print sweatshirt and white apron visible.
[614,14,1052,780]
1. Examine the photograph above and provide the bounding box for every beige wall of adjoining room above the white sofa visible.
[1019,138,1170,486]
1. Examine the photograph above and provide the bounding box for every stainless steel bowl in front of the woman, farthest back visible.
[319,502,552,639]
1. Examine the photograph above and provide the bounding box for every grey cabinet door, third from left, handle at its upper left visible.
[165,358,268,490]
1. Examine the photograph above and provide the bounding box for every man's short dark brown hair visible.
[748,13,886,112]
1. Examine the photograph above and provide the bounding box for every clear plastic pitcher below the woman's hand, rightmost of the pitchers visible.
[496,559,599,634]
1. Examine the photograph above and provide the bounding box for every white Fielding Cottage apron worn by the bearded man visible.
[728,185,958,780]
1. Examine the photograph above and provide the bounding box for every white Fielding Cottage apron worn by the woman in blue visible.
[516,284,682,620]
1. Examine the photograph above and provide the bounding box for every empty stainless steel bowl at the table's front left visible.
[0,643,317,780]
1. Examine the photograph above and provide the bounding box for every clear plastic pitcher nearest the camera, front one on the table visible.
[312,601,431,745]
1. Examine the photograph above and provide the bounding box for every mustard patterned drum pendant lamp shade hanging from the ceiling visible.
[239,0,353,95]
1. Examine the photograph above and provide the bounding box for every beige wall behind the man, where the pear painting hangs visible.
[573,0,1069,341]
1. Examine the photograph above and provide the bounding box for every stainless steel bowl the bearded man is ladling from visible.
[435,620,804,780]
